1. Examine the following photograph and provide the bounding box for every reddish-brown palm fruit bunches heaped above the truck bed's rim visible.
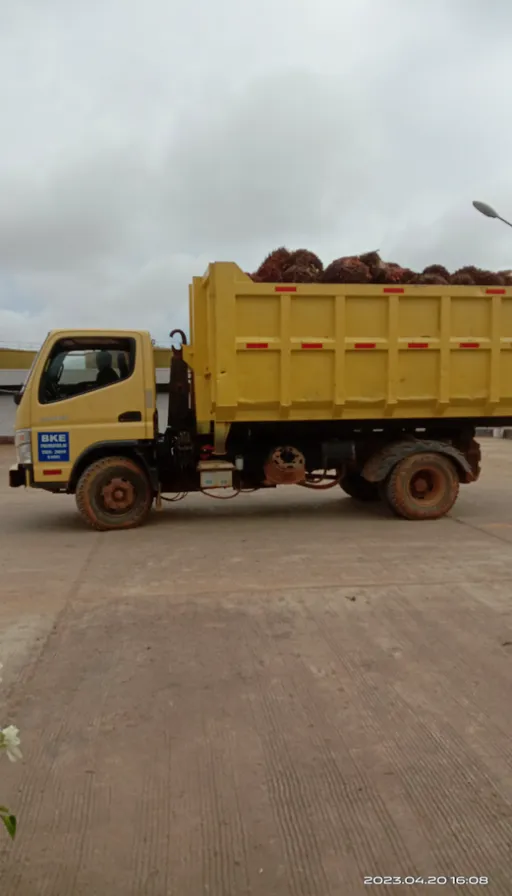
[249,247,512,286]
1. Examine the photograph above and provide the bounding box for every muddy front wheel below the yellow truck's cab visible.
[76,457,153,532]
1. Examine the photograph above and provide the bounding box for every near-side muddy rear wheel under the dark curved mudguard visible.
[385,453,459,520]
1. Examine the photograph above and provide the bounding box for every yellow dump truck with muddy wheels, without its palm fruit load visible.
[10,263,512,530]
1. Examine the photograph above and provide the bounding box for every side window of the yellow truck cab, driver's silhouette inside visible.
[39,336,135,404]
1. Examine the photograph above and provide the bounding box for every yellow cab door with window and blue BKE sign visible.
[31,331,154,485]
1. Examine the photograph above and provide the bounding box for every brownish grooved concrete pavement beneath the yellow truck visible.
[0,440,512,896]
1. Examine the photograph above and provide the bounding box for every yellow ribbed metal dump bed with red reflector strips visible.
[184,262,512,423]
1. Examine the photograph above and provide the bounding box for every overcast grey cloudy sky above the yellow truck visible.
[0,0,512,343]
